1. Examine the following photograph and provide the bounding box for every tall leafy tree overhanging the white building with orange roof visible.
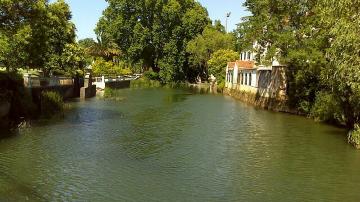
[237,0,329,113]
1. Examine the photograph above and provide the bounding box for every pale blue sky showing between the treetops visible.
[57,0,248,39]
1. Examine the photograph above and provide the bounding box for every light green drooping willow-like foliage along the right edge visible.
[320,0,360,127]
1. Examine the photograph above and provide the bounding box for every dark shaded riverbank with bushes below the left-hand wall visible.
[0,72,76,130]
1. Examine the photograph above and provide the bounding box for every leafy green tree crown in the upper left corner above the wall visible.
[0,0,82,74]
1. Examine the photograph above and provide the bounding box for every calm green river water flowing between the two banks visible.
[0,88,360,202]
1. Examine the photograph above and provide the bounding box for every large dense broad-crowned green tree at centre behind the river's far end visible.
[96,0,210,82]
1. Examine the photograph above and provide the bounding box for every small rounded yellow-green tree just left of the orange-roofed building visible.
[208,49,239,85]
